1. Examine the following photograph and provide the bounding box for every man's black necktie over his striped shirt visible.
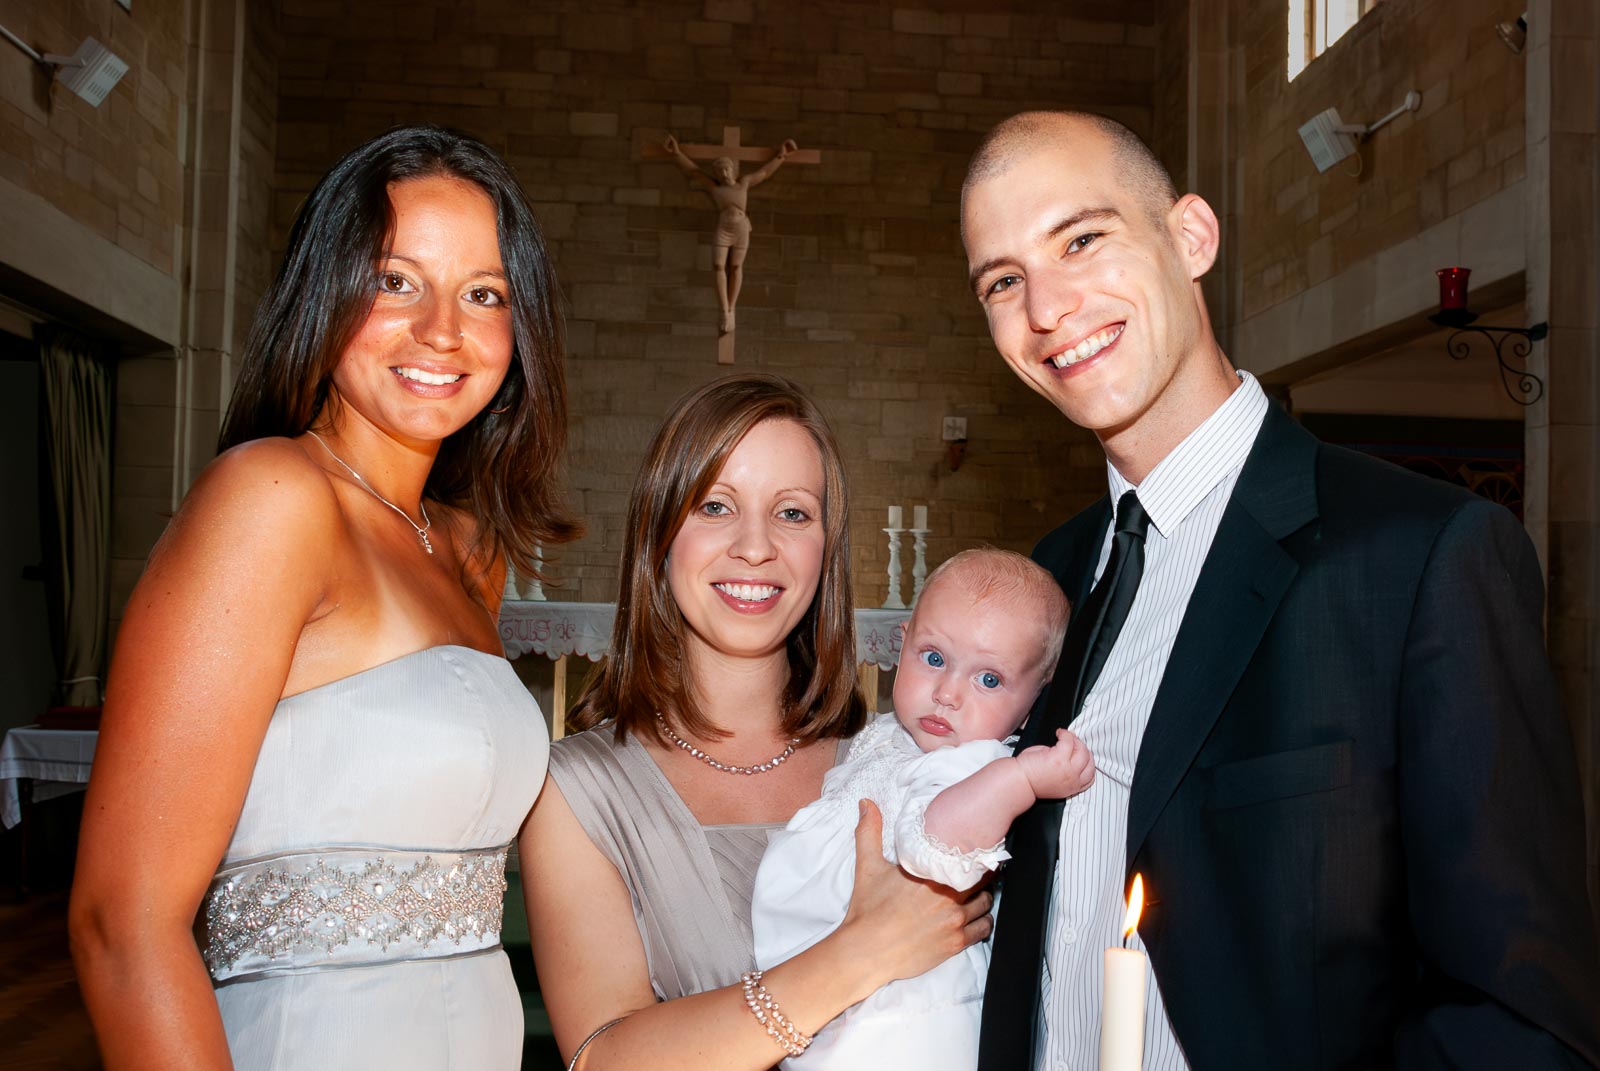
[978,491,1150,1071]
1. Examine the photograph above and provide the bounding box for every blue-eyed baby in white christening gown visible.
[750,549,1094,1071]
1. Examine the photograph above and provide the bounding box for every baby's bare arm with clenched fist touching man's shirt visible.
[923,728,1094,852]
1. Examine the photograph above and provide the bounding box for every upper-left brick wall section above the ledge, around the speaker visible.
[0,0,189,274]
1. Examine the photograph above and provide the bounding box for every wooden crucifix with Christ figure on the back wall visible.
[645,126,822,365]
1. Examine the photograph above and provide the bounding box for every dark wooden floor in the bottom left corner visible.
[0,890,101,1071]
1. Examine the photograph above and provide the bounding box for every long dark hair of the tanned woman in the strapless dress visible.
[218,125,581,575]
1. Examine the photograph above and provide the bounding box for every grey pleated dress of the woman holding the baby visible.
[550,725,848,1001]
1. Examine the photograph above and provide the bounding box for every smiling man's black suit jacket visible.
[1024,407,1600,1071]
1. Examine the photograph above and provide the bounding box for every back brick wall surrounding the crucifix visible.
[275,0,1155,605]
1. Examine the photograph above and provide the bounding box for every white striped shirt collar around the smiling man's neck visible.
[1106,370,1270,538]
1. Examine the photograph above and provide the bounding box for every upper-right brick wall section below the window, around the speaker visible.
[1234,0,1525,317]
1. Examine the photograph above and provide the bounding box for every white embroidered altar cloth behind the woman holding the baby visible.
[499,602,910,671]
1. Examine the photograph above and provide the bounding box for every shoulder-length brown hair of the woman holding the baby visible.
[570,375,867,741]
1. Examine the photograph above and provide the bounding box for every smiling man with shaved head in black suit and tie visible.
[962,112,1600,1071]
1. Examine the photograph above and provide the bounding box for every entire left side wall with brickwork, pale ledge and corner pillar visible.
[0,0,278,643]
